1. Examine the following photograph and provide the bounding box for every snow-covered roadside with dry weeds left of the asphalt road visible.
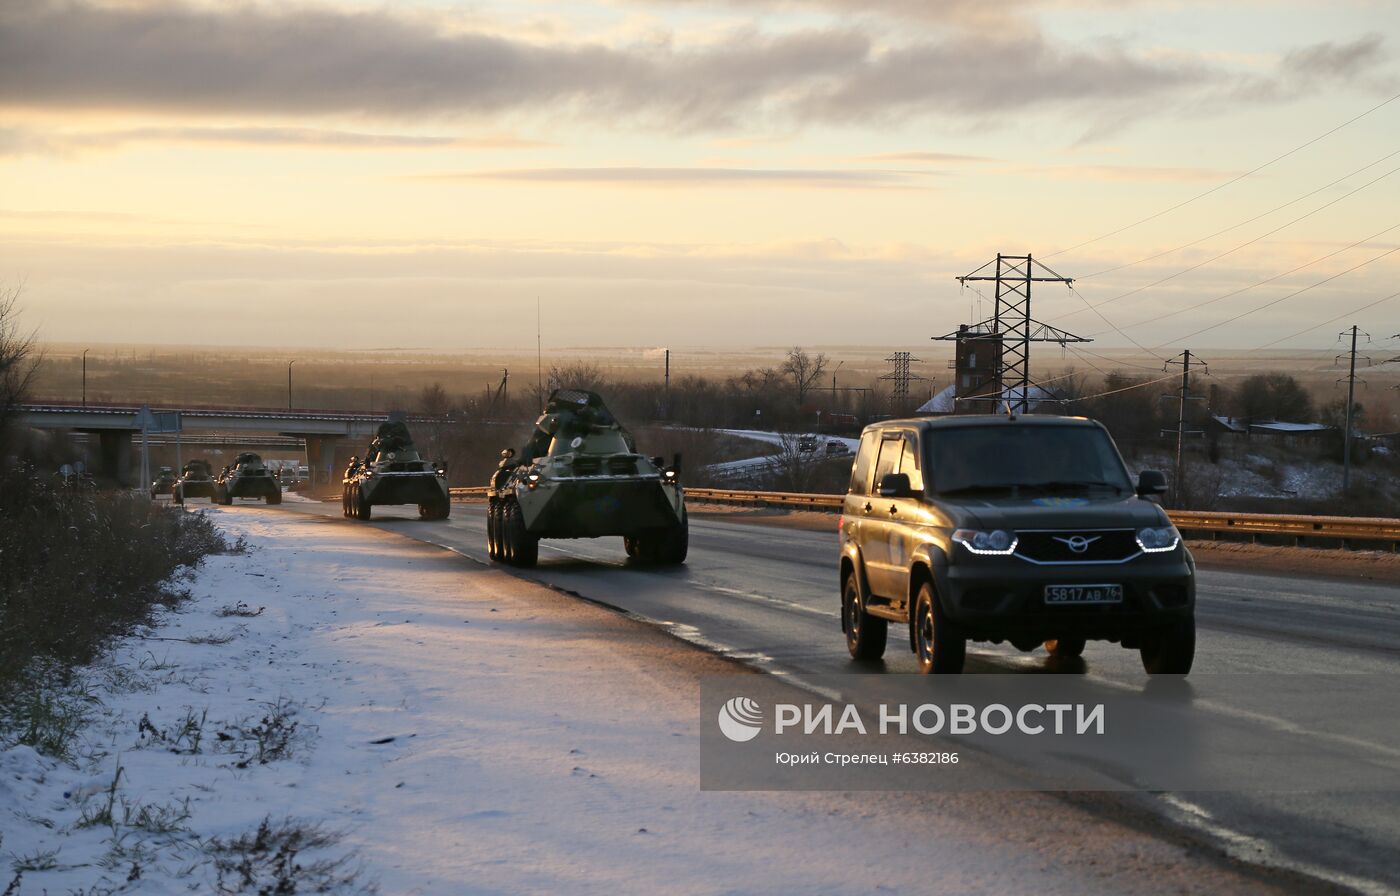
[0,507,1304,895]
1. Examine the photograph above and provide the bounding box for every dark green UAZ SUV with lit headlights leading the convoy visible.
[840,414,1196,675]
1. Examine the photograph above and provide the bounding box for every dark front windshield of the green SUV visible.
[924,426,1133,496]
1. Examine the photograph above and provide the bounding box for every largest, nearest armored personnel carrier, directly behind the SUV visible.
[486,389,690,567]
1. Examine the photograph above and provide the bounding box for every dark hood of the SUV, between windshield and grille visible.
[938,494,1168,529]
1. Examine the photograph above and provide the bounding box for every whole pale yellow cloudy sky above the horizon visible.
[0,0,1400,350]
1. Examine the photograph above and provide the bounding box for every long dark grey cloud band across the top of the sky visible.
[0,0,1386,130]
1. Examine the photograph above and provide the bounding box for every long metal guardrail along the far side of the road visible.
[452,487,1400,550]
